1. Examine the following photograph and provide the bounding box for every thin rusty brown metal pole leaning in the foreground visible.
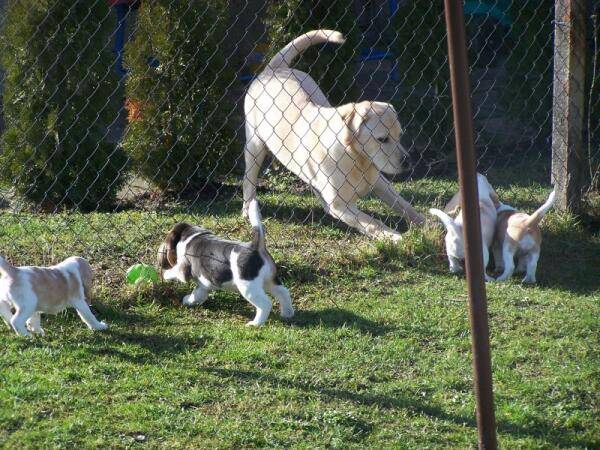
[444,0,497,449]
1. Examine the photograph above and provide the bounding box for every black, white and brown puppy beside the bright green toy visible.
[158,200,294,326]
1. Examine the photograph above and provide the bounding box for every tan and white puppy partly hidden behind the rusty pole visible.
[429,173,499,281]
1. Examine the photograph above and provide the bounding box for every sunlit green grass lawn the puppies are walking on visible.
[0,180,600,449]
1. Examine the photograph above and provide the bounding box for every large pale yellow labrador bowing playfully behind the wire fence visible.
[244,30,424,240]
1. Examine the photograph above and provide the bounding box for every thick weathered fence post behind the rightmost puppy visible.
[552,0,587,211]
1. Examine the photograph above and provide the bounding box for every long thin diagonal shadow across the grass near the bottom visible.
[200,367,597,448]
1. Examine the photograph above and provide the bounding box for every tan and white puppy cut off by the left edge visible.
[0,256,108,336]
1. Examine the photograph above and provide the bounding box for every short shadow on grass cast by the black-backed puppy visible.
[291,308,395,336]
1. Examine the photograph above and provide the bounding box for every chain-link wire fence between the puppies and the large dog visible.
[0,0,600,282]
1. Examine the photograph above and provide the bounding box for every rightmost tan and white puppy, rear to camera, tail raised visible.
[492,191,556,283]
